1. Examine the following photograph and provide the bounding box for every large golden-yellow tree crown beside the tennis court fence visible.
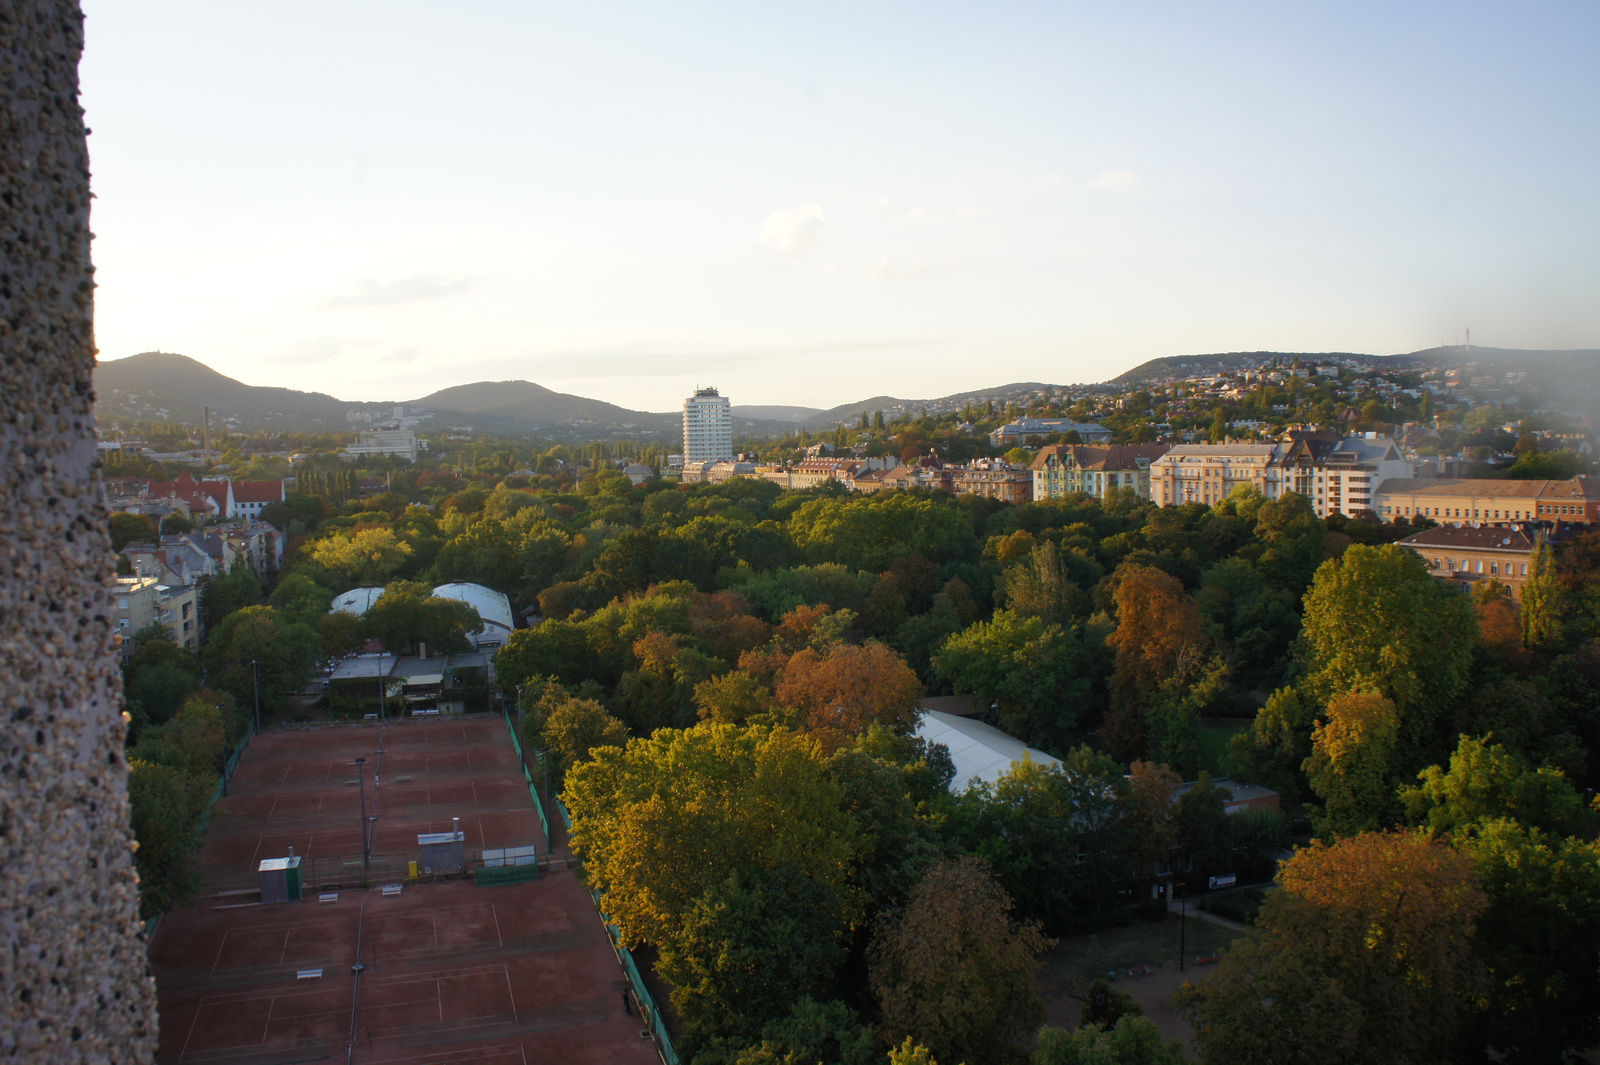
[565,723,862,943]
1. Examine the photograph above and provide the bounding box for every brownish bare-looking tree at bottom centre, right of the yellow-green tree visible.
[869,857,1051,1065]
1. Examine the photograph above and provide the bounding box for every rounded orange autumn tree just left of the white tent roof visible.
[773,643,922,748]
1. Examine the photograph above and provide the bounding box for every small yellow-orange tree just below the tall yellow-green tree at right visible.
[1306,692,1400,836]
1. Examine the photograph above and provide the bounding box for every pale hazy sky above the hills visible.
[83,0,1600,409]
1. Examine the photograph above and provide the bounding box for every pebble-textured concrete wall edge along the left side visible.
[0,0,155,1065]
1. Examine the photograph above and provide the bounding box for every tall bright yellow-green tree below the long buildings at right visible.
[1302,544,1477,771]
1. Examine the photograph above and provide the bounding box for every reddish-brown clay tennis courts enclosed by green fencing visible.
[150,715,661,1065]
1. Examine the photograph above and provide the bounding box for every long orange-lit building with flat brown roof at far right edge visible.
[1373,477,1600,525]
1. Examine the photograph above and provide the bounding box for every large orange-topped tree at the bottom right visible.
[1178,832,1486,1065]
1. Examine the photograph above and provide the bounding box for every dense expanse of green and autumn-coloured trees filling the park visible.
[126,470,1600,1065]
